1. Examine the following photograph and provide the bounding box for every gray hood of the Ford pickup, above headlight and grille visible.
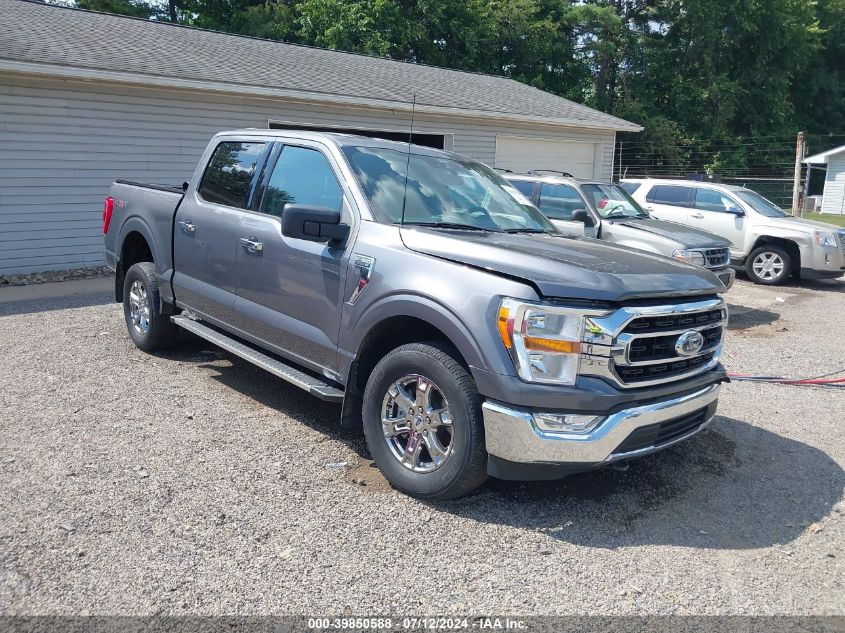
[401,227,725,302]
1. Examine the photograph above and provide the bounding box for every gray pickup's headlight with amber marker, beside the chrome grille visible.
[497,298,588,385]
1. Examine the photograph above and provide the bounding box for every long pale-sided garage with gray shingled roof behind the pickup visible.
[0,0,641,273]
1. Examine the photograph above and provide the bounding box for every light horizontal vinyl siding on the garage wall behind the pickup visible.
[0,74,614,274]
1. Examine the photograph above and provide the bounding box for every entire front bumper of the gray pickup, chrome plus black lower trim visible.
[482,384,720,479]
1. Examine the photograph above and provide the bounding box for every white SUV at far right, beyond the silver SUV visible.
[622,179,845,285]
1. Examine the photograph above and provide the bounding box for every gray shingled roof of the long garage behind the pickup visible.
[0,0,641,131]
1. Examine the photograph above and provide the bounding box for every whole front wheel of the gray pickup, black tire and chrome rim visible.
[362,342,487,499]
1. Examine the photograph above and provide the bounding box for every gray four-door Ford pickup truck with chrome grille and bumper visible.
[104,130,727,498]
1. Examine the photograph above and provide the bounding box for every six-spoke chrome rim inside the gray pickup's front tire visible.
[381,374,453,473]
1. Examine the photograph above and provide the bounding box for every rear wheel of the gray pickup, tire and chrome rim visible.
[123,262,179,352]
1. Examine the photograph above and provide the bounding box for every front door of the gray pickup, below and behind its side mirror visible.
[235,141,352,371]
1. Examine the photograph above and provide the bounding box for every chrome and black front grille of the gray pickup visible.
[581,299,727,388]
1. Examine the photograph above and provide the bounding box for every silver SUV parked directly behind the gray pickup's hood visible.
[505,172,736,288]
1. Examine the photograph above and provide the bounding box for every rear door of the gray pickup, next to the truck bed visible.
[173,140,269,326]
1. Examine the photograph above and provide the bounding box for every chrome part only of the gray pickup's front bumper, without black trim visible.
[482,384,719,464]
